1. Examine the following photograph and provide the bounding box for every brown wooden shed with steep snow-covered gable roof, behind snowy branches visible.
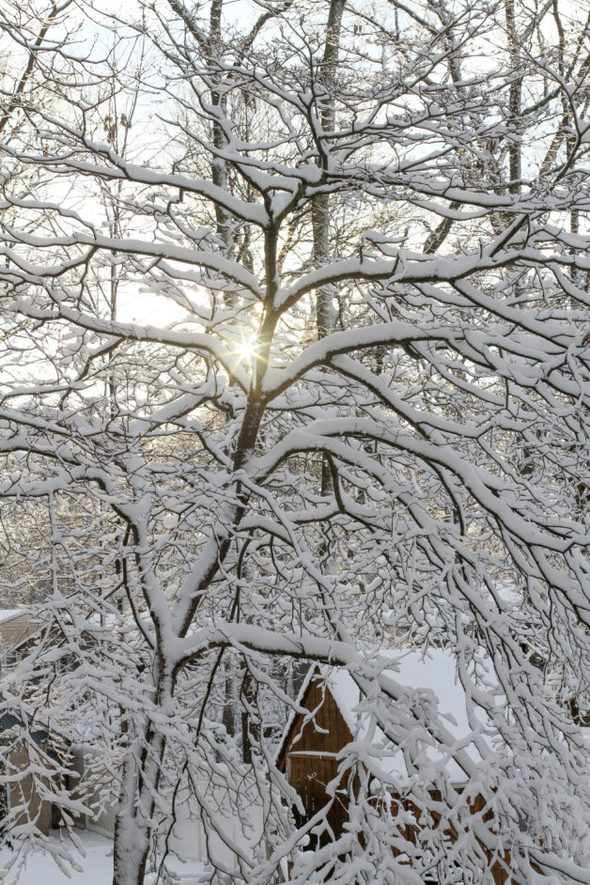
[277,649,509,885]
